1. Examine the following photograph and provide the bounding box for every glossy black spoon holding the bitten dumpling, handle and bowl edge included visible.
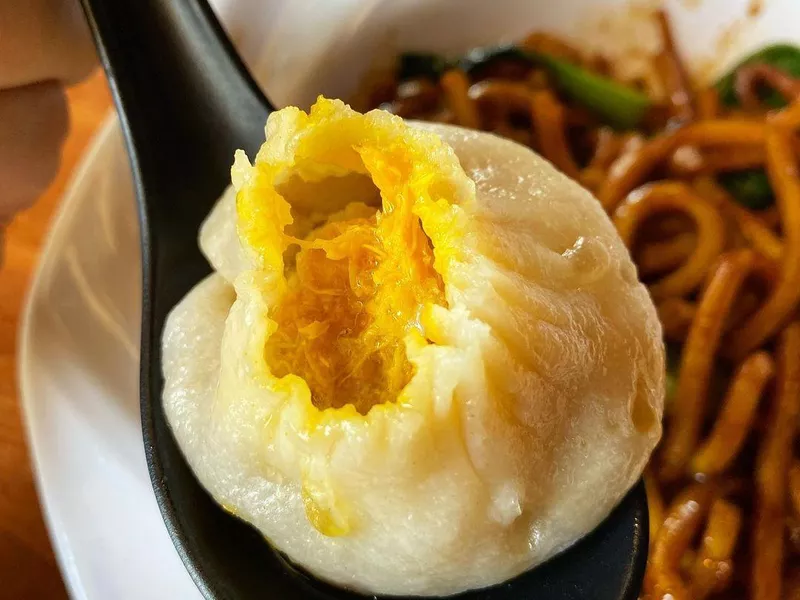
[75,0,647,600]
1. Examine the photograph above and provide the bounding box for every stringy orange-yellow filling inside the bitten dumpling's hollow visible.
[266,196,445,414]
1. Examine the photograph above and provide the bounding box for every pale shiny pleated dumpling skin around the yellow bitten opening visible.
[163,110,664,595]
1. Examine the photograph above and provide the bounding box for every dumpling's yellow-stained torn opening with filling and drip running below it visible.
[231,98,475,536]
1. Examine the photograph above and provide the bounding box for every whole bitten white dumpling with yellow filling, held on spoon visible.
[163,99,664,595]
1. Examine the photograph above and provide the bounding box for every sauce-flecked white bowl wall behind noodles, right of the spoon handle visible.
[218,0,800,107]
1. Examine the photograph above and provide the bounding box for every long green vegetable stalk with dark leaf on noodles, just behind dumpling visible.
[399,45,652,129]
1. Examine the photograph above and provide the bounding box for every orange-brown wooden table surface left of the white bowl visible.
[0,73,111,600]
